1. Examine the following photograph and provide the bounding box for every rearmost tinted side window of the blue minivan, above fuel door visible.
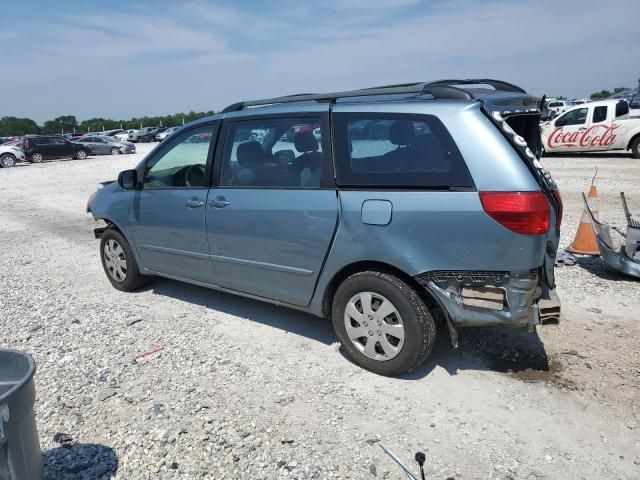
[334,113,473,189]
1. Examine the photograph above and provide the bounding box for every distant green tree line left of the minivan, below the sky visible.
[0,111,215,137]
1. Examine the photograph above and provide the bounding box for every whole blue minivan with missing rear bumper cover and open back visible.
[87,80,562,375]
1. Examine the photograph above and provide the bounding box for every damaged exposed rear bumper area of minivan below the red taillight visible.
[416,270,560,333]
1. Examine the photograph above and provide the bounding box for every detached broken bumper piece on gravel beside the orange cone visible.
[582,193,640,278]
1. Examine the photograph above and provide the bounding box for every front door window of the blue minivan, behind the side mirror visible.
[144,125,214,189]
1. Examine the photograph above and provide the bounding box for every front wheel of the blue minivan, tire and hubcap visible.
[100,227,147,292]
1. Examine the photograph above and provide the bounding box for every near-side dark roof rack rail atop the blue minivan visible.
[221,82,474,113]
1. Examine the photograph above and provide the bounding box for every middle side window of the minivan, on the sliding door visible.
[220,116,330,188]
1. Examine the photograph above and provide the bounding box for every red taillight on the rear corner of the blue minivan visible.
[480,192,551,235]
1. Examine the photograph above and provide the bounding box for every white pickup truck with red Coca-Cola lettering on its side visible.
[540,100,640,158]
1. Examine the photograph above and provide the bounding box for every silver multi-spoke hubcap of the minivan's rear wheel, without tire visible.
[344,292,405,361]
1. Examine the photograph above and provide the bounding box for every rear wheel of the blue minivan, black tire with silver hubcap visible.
[332,271,436,376]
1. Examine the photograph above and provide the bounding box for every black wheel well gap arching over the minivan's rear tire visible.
[322,260,444,327]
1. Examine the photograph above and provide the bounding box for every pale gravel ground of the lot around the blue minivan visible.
[0,145,640,479]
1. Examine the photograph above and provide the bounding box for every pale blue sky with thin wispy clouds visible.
[0,0,640,123]
